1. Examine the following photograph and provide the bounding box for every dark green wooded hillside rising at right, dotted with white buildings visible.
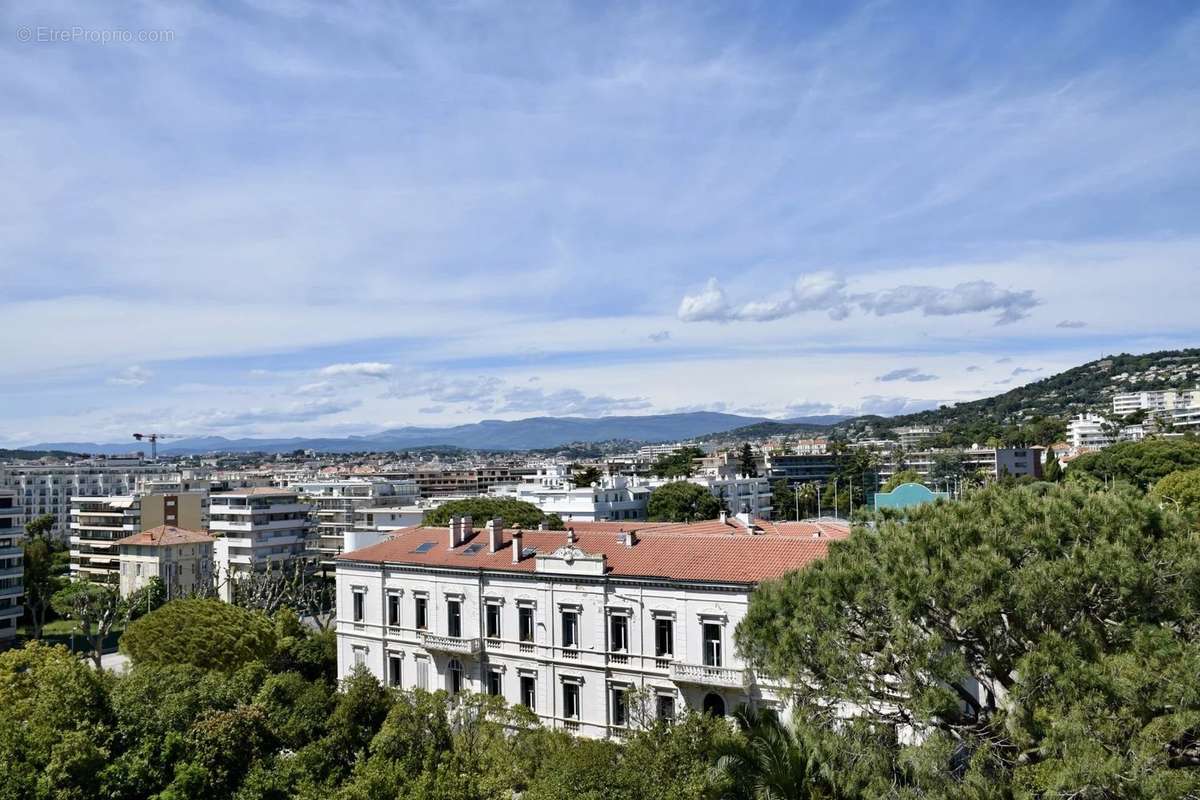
[835,348,1200,445]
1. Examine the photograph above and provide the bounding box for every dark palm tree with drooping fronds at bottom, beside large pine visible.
[709,706,824,800]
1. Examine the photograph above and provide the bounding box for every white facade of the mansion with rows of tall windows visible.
[337,529,796,738]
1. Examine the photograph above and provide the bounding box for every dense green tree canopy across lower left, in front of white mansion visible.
[0,618,746,800]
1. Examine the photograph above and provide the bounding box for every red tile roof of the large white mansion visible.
[338,523,835,584]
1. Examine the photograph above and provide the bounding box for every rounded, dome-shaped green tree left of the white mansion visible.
[121,600,276,670]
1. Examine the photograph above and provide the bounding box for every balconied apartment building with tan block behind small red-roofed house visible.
[68,492,208,583]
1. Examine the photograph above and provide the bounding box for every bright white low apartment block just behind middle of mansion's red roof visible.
[492,467,652,522]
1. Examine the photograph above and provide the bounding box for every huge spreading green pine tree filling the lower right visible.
[736,483,1200,798]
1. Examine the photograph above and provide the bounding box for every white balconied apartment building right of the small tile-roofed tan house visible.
[209,487,312,601]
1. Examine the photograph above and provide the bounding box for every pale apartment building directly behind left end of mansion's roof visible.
[292,479,419,567]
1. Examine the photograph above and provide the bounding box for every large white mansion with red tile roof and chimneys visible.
[337,518,846,736]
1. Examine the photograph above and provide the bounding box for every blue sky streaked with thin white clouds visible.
[0,1,1200,444]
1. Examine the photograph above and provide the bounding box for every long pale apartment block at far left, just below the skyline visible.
[0,458,163,539]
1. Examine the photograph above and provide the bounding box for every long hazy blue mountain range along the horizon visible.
[21,411,844,455]
